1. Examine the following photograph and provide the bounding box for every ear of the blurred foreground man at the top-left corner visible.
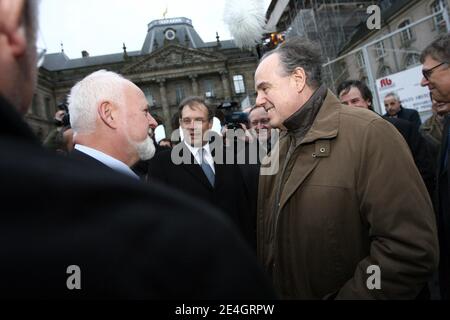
[0,0,28,57]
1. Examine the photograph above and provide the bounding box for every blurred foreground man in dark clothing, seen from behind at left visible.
[0,0,273,300]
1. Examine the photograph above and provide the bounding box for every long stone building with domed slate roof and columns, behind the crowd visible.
[27,17,258,138]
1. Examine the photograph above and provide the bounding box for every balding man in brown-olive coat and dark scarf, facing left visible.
[255,38,439,299]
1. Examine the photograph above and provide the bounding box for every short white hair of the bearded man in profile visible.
[69,70,129,134]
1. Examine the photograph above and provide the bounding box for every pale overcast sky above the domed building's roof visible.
[38,0,270,59]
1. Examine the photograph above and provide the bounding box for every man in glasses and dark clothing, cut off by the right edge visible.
[420,34,450,300]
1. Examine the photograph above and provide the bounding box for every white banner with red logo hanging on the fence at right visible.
[377,66,431,114]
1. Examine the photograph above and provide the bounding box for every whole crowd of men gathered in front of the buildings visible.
[0,0,450,300]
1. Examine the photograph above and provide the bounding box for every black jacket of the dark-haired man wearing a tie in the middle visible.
[148,142,256,247]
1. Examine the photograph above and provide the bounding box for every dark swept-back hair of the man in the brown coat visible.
[261,36,322,89]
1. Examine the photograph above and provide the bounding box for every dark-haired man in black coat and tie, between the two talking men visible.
[148,97,251,248]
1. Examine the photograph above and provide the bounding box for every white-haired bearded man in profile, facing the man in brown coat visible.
[69,70,157,178]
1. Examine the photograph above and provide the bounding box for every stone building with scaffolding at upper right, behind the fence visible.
[266,0,450,118]
